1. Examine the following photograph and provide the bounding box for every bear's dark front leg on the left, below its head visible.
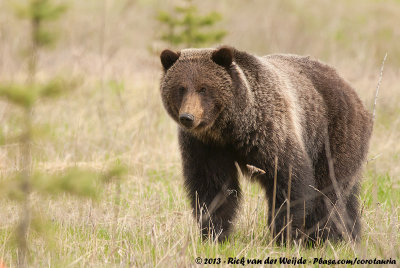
[179,131,241,241]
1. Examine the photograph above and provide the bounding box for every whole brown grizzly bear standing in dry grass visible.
[160,46,372,244]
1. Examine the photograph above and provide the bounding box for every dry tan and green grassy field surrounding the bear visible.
[0,0,400,267]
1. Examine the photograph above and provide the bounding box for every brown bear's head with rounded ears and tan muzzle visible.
[160,46,250,136]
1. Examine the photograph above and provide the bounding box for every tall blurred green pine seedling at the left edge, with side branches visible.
[0,0,123,267]
